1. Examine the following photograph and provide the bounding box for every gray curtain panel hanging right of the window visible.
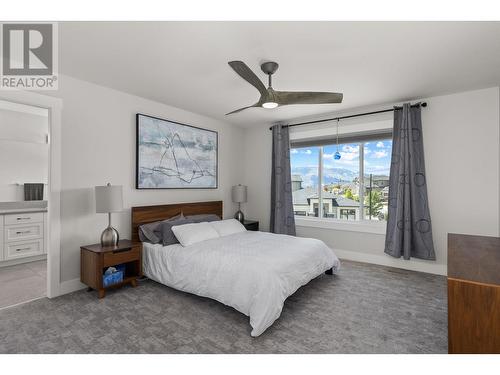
[385,103,436,260]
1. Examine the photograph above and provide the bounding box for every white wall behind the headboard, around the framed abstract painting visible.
[44,76,243,281]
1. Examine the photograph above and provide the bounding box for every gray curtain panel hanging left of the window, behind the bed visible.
[270,125,295,236]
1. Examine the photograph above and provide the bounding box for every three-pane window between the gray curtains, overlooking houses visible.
[290,134,392,221]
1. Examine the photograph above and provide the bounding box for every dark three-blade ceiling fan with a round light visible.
[226,61,343,115]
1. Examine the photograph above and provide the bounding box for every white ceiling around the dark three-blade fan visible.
[59,22,500,126]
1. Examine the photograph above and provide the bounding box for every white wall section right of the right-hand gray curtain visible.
[422,87,500,272]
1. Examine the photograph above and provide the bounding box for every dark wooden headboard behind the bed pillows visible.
[132,201,222,242]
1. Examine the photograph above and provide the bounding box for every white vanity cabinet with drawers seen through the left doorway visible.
[0,212,47,261]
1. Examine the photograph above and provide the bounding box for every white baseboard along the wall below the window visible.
[334,248,448,276]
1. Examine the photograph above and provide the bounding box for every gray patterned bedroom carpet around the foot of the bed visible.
[0,261,447,353]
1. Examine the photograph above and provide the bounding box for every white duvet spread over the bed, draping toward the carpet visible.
[143,231,340,336]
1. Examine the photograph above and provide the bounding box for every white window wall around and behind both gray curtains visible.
[244,87,500,273]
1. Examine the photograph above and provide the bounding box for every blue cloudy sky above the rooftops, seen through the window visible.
[291,140,392,187]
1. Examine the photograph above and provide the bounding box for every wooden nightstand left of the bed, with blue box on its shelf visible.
[80,240,142,298]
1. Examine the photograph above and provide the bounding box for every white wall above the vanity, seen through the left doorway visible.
[0,100,49,202]
